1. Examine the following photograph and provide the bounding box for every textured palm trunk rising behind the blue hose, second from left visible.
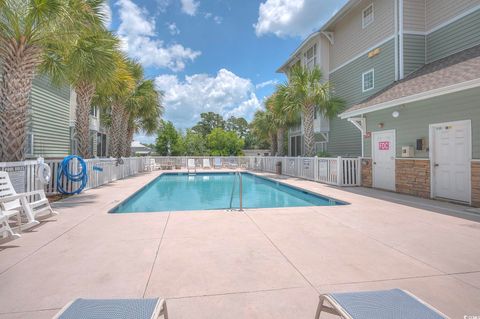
[75,82,95,158]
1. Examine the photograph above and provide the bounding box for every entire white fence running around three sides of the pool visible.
[0,156,361,195]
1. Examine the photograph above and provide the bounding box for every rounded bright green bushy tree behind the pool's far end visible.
[207,128,244,156]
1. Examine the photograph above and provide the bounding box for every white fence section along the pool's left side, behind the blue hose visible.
[0,157,149,195]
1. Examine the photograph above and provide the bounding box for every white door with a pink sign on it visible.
[372,130,395,191]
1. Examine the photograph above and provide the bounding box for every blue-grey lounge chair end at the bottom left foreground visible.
[53,298,168,319]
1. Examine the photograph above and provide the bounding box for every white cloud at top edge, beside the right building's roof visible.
[254,0,345,37]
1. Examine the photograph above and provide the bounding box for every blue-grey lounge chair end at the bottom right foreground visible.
[315,289,448,319]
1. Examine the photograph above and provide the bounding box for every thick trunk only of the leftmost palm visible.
[0,37,41,162]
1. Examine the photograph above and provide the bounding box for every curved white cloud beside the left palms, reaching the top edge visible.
[117,0,201,71]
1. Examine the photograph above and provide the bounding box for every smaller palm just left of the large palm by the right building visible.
[269,84,300,156]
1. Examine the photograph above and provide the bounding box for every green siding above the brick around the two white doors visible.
[365,88,480,159]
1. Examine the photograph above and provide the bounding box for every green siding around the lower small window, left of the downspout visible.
[330,40,395,108]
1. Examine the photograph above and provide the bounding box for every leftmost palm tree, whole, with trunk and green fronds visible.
[0,0,102,161]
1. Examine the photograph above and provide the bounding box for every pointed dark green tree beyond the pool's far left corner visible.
[155,121,184,156]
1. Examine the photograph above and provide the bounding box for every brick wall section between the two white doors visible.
[395,159,430,198]
